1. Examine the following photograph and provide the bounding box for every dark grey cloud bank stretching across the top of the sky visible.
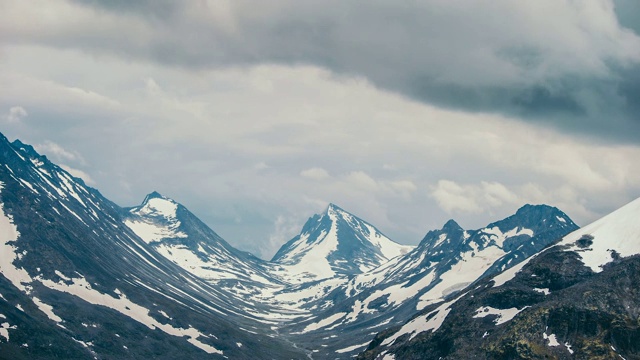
[28,0,640,143]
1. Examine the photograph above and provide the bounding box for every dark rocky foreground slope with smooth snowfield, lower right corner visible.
[359,199,640,359]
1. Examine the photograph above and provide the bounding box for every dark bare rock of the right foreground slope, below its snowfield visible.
[358,242,640,359]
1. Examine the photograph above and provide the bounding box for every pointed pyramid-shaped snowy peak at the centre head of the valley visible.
[272,204,413,281]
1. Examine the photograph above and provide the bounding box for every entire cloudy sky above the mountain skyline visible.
[0,0,640,258]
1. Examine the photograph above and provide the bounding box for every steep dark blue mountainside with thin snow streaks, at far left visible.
[0,135,305,359]
